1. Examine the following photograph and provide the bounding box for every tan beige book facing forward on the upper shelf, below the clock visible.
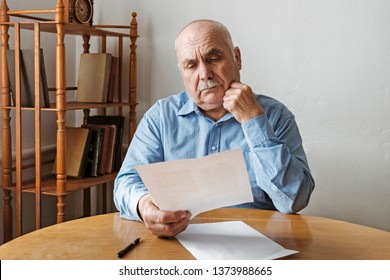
[76,53,112,103]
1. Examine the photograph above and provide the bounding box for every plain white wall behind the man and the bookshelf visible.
[0,0,390,243]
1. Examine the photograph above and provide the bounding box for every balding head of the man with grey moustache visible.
[176,22,241,114]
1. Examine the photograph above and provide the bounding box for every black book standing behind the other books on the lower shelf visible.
[87,115,125,171]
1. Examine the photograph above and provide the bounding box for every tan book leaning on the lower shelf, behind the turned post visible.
[53,127,92,177]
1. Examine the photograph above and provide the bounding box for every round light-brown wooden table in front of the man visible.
[0,208,390,260]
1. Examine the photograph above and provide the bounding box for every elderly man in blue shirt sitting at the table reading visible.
[114,20,314,236]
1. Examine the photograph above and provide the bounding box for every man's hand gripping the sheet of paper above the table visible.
[138,194,191,237]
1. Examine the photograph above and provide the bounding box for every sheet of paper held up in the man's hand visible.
[136,150,253,217]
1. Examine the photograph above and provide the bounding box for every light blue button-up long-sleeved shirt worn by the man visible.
[114,92,314,220]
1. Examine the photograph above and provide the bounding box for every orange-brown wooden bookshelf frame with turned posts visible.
[0,0,138,242]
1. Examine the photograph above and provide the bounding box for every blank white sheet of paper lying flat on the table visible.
[176,221,298,260]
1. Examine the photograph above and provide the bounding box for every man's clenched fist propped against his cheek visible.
[223,82,264,123]
